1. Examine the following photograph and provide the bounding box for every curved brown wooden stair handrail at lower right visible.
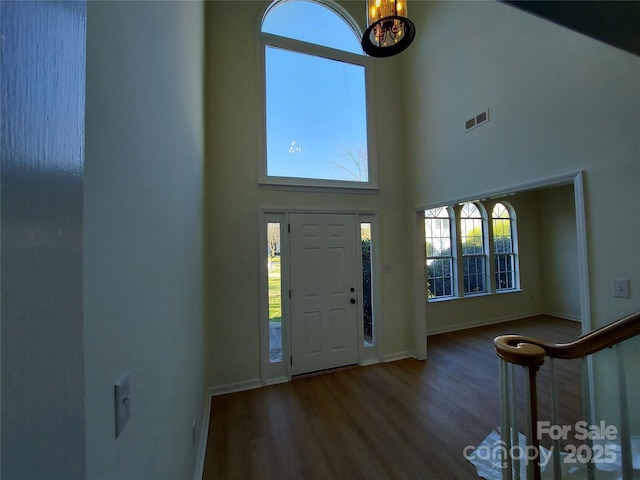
[493,312,640,367]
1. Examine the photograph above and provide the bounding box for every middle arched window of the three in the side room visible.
[460,203,487,294]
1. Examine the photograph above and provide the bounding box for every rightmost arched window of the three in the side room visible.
[491,203,517,291]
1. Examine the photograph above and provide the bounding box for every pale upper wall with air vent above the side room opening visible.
[402,1,640,326]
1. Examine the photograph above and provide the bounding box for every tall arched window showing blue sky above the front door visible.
[261,0,376,188]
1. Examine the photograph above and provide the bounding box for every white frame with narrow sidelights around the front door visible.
[258,208,384,385]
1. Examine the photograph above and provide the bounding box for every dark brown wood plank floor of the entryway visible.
[203,317,581,480]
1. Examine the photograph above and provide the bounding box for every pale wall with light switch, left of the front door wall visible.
[84,2,205,480]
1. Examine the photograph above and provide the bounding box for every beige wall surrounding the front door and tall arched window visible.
[205,1,414,386]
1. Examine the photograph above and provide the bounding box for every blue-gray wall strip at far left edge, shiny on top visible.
[0,2,86,480]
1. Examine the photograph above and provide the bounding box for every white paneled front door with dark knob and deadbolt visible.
[290,214,358,375]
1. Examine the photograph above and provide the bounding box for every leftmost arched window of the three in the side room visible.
[424,207,454,298]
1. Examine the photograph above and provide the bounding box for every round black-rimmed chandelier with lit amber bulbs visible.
[362,0,416,57]
